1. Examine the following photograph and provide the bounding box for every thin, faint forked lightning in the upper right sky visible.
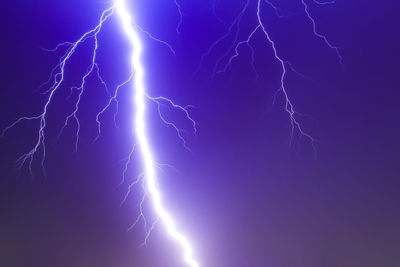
[195,0,343,156]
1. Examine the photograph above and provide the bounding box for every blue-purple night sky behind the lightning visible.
[0,0,400,267]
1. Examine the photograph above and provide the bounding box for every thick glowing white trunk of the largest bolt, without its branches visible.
[115,0,199,267]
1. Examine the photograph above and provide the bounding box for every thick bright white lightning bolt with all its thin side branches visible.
[2,0,199,267]
